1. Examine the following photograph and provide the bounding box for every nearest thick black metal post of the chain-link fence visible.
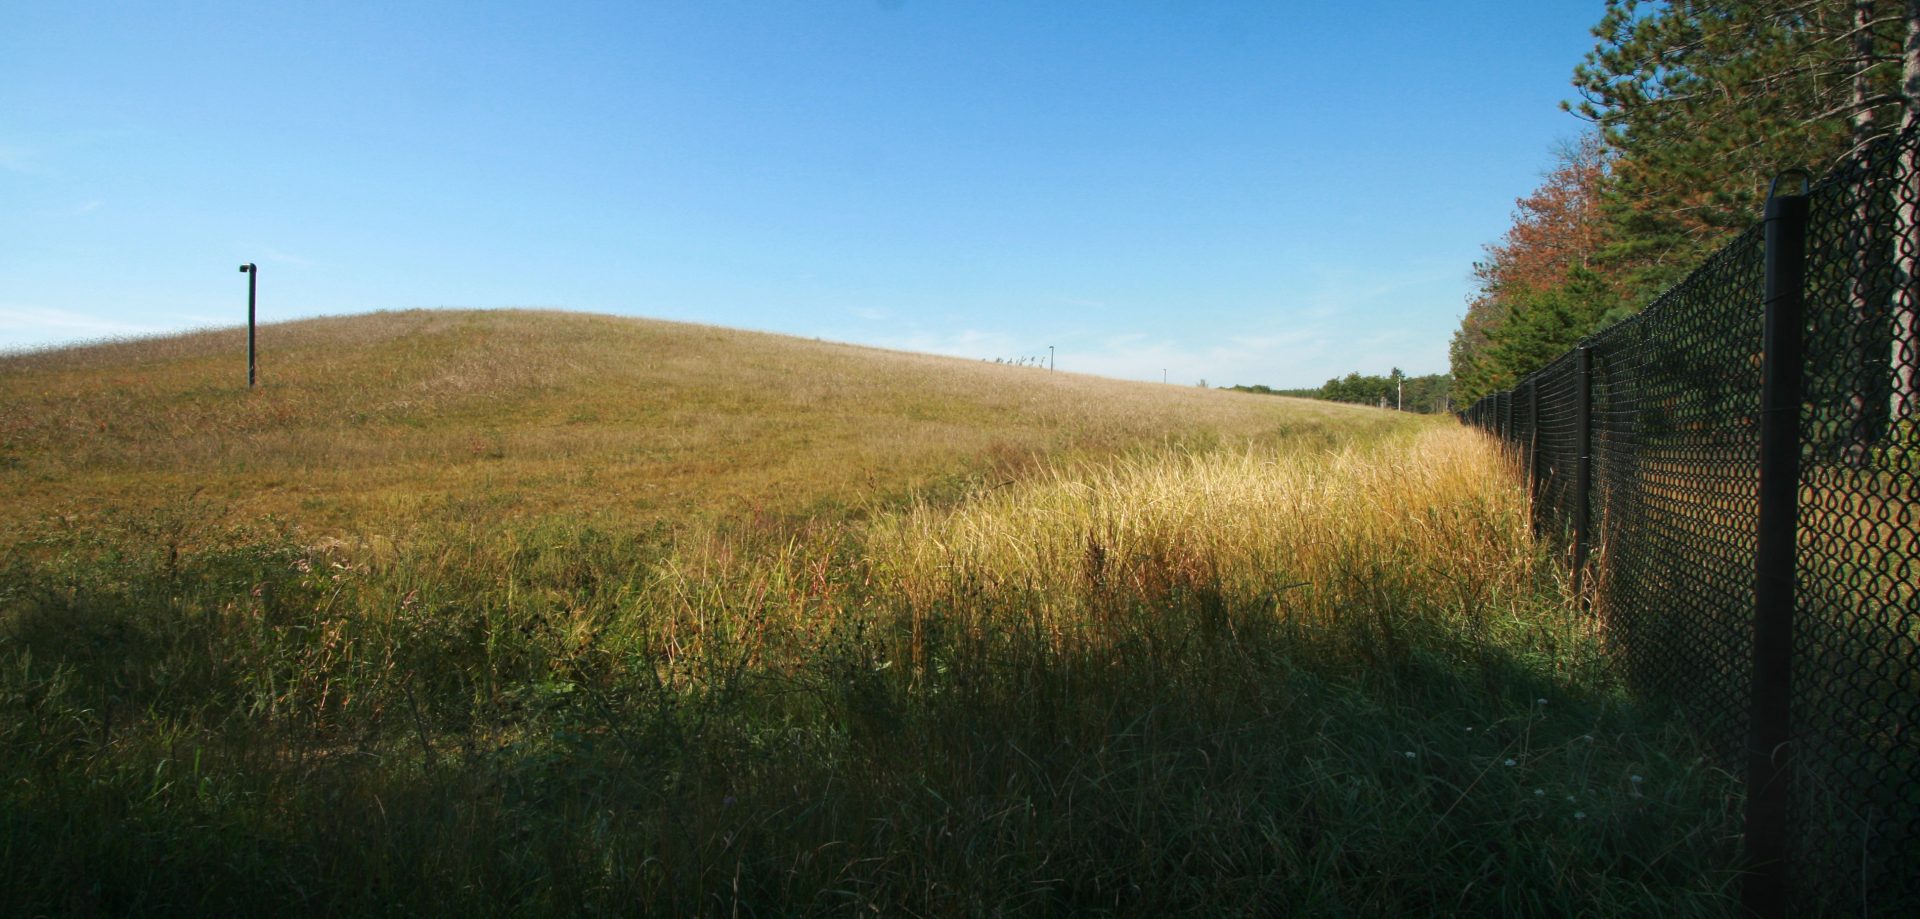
[1740,177,1807,915]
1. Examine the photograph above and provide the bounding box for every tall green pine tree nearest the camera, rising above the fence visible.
[1567,0,1905,301]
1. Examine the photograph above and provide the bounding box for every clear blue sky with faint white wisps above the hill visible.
[0,0,1601,386]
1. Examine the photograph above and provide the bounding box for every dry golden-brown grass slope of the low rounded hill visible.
[0,311,1409,533]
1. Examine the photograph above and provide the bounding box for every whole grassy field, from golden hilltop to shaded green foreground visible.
[0,313,1741,915]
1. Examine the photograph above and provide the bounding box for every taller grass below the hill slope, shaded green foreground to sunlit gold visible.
[0,430,1738,915]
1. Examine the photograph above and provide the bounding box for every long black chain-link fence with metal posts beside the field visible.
[1461,132,1920,915]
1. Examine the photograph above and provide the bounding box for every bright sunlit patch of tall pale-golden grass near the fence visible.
[870,426,1534,627]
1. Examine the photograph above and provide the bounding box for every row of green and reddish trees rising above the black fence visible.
[1450,0,1920,405]
